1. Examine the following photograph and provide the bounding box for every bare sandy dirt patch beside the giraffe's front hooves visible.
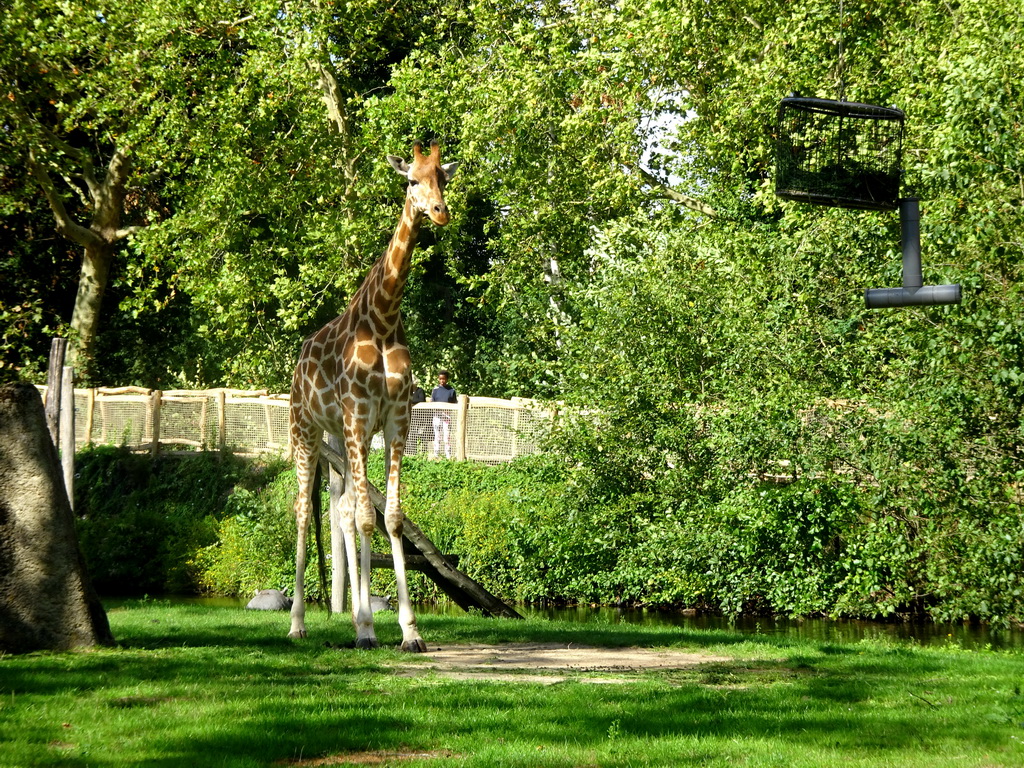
[391,643,731,684]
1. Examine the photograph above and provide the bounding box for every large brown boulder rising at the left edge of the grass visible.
[0,384,114,653]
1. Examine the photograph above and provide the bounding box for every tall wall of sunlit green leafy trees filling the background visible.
[9,0,1024,616]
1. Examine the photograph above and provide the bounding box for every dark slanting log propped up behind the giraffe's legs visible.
[321,442,522,618]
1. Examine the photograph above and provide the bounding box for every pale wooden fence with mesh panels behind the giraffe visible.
[40,387,554,464]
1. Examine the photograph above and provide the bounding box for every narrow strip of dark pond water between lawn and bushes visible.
[155,597,1024,650]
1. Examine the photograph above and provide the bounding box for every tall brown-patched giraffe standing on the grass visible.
[289,141,459,652]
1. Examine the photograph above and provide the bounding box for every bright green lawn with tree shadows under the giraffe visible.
[0,601,1024,768]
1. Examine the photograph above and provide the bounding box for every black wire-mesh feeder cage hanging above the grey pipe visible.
[775,96,904,211]
